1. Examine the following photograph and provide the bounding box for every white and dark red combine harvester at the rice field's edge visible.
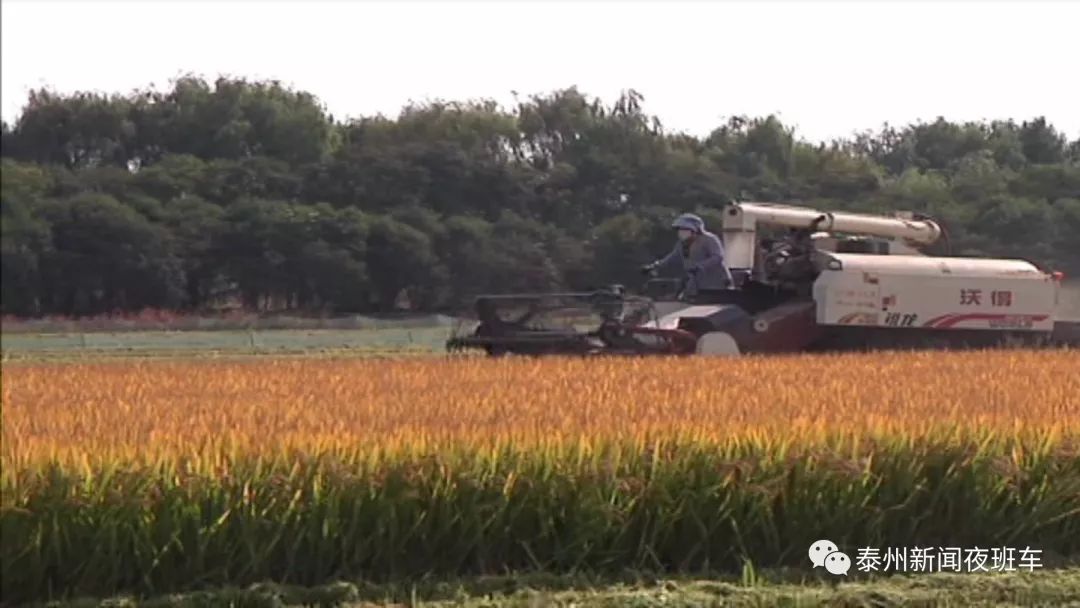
[446,203,1080,355]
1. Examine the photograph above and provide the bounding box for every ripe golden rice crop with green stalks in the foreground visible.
[0,351,1080,602]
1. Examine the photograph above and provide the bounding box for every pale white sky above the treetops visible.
[0,0,1080,140]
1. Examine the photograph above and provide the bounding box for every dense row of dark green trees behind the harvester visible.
[0,77,1080,315]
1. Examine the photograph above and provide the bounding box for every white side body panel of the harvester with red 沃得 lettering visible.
[813,253,1058,332]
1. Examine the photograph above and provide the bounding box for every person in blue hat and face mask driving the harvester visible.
[642,213,734,298]
